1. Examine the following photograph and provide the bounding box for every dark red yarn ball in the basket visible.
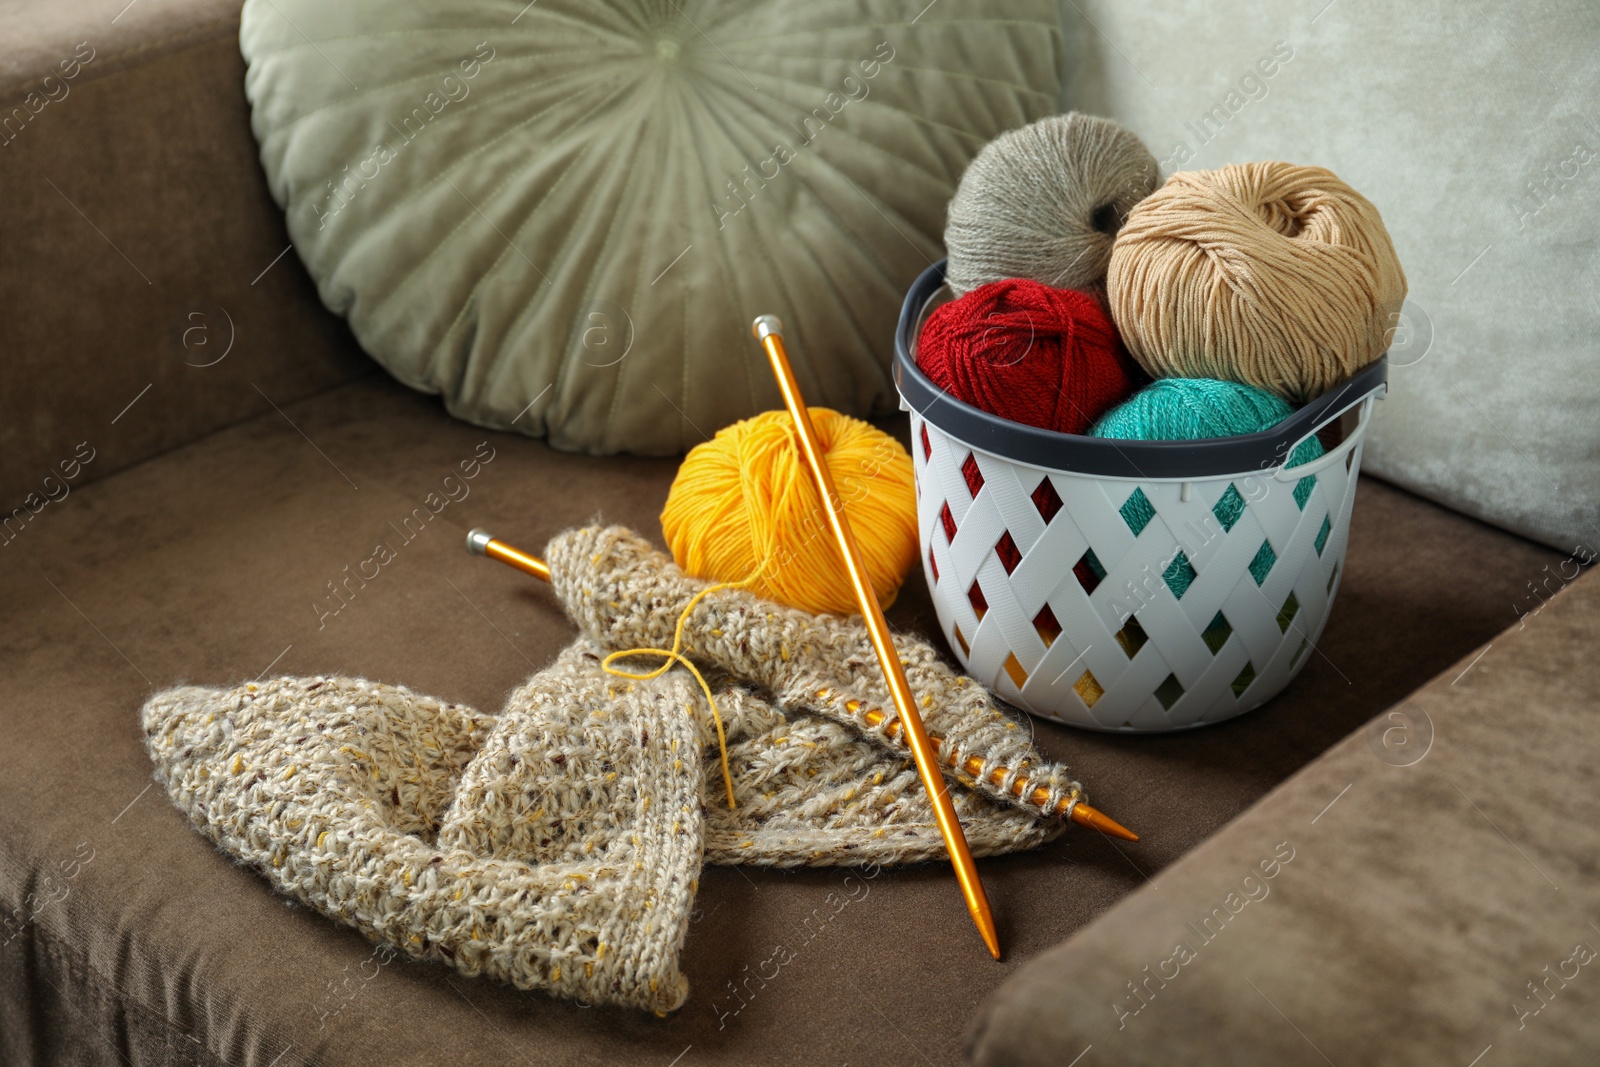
[917,278,1141,434]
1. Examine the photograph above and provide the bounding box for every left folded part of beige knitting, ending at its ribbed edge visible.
[144,662,702,1011]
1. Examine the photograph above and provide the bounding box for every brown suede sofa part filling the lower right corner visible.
[971,566,1600,1067]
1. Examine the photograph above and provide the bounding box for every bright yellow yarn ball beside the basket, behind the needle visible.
[661,408,917,614]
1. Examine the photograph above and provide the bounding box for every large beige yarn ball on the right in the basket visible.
[1106,163,1406,402]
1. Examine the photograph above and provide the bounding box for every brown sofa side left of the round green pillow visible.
[0,0,371,521]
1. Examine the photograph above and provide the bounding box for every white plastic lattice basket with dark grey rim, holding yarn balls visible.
[894,262,1387,733]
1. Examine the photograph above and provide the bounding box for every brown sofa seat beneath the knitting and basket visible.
[0,376,1560,1067]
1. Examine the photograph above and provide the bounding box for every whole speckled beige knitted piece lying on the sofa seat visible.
[144,528,1074,1013]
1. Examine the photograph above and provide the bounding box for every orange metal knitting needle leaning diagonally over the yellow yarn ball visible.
[750,315,1000,960]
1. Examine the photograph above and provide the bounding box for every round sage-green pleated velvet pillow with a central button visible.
[240,0,1061,454]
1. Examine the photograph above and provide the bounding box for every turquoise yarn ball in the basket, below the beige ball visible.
[1090,378,1322,597]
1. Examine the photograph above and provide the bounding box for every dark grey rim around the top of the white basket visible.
[894,259,1389,478]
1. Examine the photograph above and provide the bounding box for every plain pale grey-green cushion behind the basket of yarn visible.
[1062,0,1600,559]
